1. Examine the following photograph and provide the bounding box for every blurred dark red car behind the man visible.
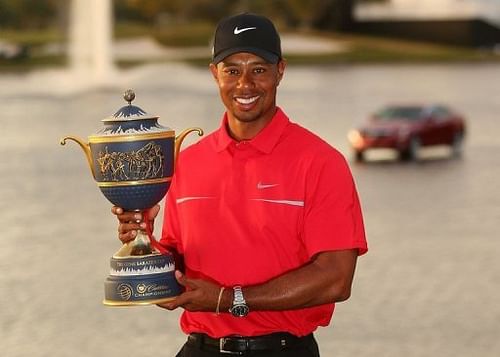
[348,105,465,161]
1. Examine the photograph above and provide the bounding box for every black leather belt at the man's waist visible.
[188,332,313,355]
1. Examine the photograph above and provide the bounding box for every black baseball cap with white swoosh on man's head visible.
[212,13,281,64]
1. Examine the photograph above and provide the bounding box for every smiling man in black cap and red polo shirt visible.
[113,14,367,356]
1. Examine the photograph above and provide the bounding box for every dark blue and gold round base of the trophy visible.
[103,253,181,306]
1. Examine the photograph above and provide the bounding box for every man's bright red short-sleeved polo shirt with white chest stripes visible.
[162,109,367,337]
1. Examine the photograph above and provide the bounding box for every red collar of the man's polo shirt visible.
[215,107,290,154]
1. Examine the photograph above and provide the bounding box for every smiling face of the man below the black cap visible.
[210,52,285,123]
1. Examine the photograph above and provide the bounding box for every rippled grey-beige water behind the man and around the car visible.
[0,65,500,357]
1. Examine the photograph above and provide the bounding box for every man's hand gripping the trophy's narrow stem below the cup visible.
[111,205,160,243]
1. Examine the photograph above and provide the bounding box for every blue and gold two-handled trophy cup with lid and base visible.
[60,90,203,306]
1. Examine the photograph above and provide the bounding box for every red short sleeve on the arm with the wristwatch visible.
[303,151,368,257]
